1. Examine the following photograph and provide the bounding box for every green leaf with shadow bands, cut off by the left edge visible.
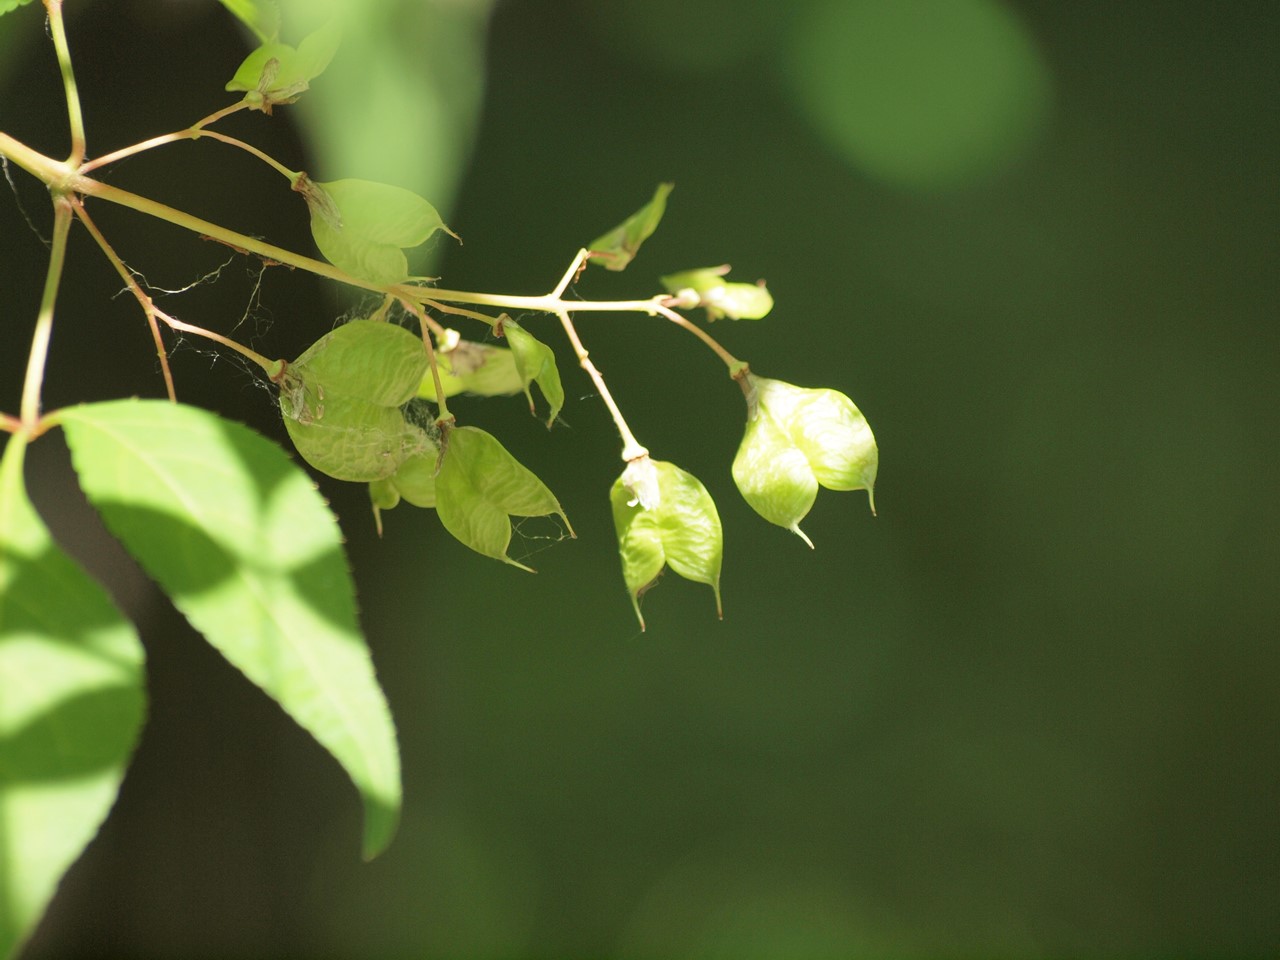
[0,436,146,956]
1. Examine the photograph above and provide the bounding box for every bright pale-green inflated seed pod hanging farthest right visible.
[733,374,879,547]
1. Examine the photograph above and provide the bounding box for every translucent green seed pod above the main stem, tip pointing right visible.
[293,174,457,287]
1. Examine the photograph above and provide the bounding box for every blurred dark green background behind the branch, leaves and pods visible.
[0,0,1280,957]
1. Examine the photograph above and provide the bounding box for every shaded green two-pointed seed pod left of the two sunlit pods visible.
[435,426,575,573]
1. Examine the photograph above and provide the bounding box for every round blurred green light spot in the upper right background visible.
[786,0,1050,189]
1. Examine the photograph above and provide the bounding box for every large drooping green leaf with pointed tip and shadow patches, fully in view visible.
[58,399,401,858]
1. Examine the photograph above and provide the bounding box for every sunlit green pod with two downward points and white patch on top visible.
[609,456,724,630]
